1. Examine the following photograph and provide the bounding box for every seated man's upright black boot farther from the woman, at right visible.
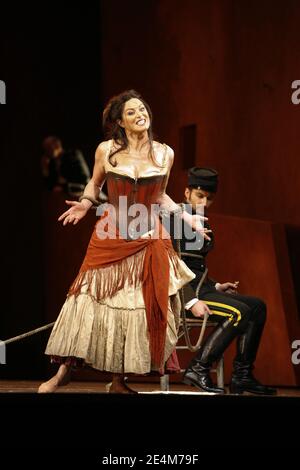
[229,321,276,395]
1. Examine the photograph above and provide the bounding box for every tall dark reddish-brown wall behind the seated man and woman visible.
[102,0,300,224]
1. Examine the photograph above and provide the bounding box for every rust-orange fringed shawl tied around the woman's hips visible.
[68,219,177,370]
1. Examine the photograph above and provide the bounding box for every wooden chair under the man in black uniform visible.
[160,252,224,391]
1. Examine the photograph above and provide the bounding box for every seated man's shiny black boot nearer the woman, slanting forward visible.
[183,319,239,393]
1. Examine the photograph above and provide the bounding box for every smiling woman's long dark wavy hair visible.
[102,90,162,166]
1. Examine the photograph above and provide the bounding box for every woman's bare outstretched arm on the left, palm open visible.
[58,142,108,225]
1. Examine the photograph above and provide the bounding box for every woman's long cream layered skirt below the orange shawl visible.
[45,250,195,374]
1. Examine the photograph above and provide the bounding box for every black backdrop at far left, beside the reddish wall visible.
[0,1,102,379]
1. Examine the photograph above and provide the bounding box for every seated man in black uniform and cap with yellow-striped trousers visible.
[171,167,276,395]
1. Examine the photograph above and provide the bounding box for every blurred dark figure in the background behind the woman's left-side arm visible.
[41,136,91,197]
